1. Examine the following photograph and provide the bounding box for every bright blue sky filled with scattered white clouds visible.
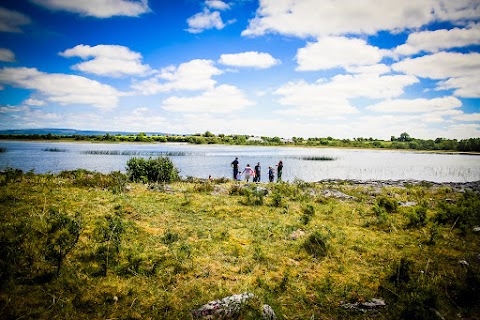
[0,0,480,140]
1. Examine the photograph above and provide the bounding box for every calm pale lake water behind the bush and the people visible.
[0,141,480,182]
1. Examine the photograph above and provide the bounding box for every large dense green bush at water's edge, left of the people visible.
[127,157,179,183]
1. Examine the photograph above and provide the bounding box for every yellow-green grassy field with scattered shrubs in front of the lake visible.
[0,170,480,319]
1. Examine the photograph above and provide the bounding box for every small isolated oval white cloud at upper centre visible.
[218,51,280,69]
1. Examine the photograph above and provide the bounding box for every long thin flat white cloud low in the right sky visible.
[367,97,462,113]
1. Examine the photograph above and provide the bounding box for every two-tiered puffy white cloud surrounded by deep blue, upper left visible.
[59,44,151,77]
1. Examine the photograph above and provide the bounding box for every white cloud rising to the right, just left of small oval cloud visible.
[132,59,222,94]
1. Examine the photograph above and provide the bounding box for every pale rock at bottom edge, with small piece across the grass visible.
[192,292,277,320]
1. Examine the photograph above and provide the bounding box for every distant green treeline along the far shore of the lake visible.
[0,131,480,152]
